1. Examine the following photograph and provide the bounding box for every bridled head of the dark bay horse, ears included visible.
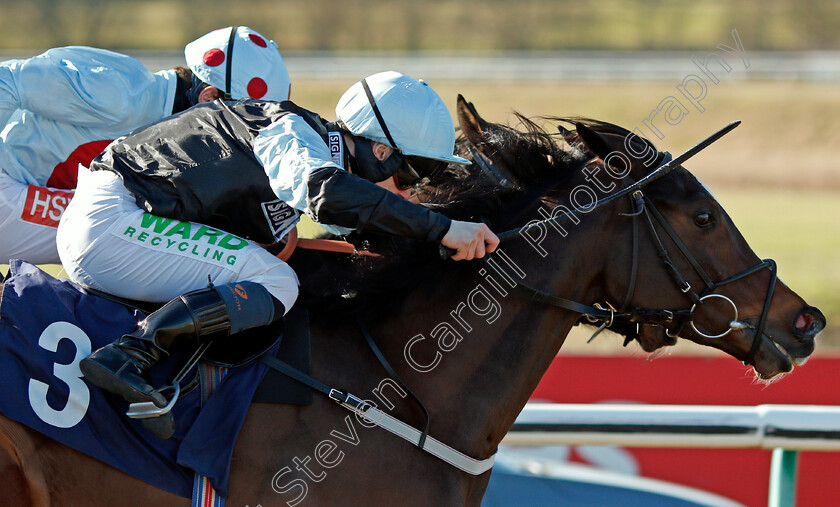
[458,97,825,379]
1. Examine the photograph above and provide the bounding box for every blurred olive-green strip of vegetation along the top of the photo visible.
[0,0,840,50]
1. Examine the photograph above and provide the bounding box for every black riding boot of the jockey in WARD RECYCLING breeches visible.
[79,287,230,407]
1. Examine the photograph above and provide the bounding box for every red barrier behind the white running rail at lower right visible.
[532,355,840,506]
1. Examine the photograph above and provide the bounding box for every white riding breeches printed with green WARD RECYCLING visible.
[57,168,298,311]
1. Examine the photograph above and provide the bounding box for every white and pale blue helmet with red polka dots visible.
[184,26,291,101]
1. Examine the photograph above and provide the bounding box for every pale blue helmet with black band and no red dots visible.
[335,71,470,165]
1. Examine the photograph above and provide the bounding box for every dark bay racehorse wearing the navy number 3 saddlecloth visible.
[0,97,825,506]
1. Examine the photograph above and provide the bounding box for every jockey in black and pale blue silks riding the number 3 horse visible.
[58,68,498,424]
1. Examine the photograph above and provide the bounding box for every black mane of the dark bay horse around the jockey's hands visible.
[290,117,628,315]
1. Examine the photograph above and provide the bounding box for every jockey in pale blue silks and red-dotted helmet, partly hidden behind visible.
[0,27,290,264]
